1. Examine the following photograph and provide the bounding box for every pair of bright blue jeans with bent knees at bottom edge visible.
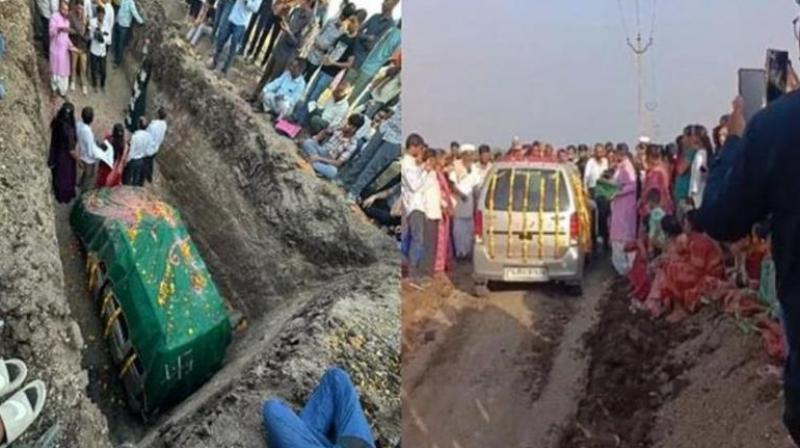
[262,368,375,448]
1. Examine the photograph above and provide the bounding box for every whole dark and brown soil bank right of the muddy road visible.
[561,281,790,448]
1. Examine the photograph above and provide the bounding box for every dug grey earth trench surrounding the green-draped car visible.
[0,0,400,447]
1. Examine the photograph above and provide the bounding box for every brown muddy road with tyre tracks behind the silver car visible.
[403,262,612,448]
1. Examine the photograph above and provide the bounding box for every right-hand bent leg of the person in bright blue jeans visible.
[298,368,375,447]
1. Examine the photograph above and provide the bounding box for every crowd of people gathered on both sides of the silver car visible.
[402,89,800,443]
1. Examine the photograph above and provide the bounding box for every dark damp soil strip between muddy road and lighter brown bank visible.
[561,281,694,448]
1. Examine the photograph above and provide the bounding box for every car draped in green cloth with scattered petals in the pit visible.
[70,186,231,418]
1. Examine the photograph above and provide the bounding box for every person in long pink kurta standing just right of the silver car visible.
[609,145,638,275]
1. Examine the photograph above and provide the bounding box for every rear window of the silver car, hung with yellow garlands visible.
[486,168,570,212]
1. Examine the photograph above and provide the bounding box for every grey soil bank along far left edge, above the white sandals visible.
[0,0,110,447]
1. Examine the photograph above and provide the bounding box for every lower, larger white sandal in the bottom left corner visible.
[0,380,47,448]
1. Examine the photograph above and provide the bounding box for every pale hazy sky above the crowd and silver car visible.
[403,0,800,147]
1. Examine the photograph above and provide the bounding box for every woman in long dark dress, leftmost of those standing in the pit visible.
[47,103,79,204]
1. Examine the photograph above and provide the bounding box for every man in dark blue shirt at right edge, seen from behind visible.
[698,91,800,444]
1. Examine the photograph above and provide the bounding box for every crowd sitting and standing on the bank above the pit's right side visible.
[186,0,402,229]
